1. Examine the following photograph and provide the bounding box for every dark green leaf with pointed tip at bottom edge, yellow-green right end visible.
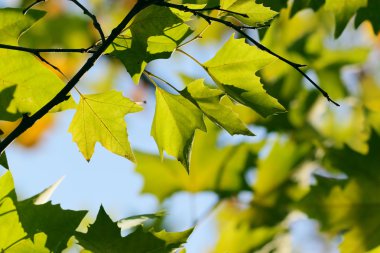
[75,207,192,253]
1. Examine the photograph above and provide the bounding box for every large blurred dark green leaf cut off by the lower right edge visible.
[300,132,380,253]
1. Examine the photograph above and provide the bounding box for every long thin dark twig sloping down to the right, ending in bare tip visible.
[156,2,339,106]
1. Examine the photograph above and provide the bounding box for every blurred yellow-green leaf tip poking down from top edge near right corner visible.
[324,0,367,38]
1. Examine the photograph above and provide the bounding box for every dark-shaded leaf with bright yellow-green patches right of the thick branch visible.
[106,6,190,83]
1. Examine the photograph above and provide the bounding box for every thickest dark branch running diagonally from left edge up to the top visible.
[0,0,151,154]
